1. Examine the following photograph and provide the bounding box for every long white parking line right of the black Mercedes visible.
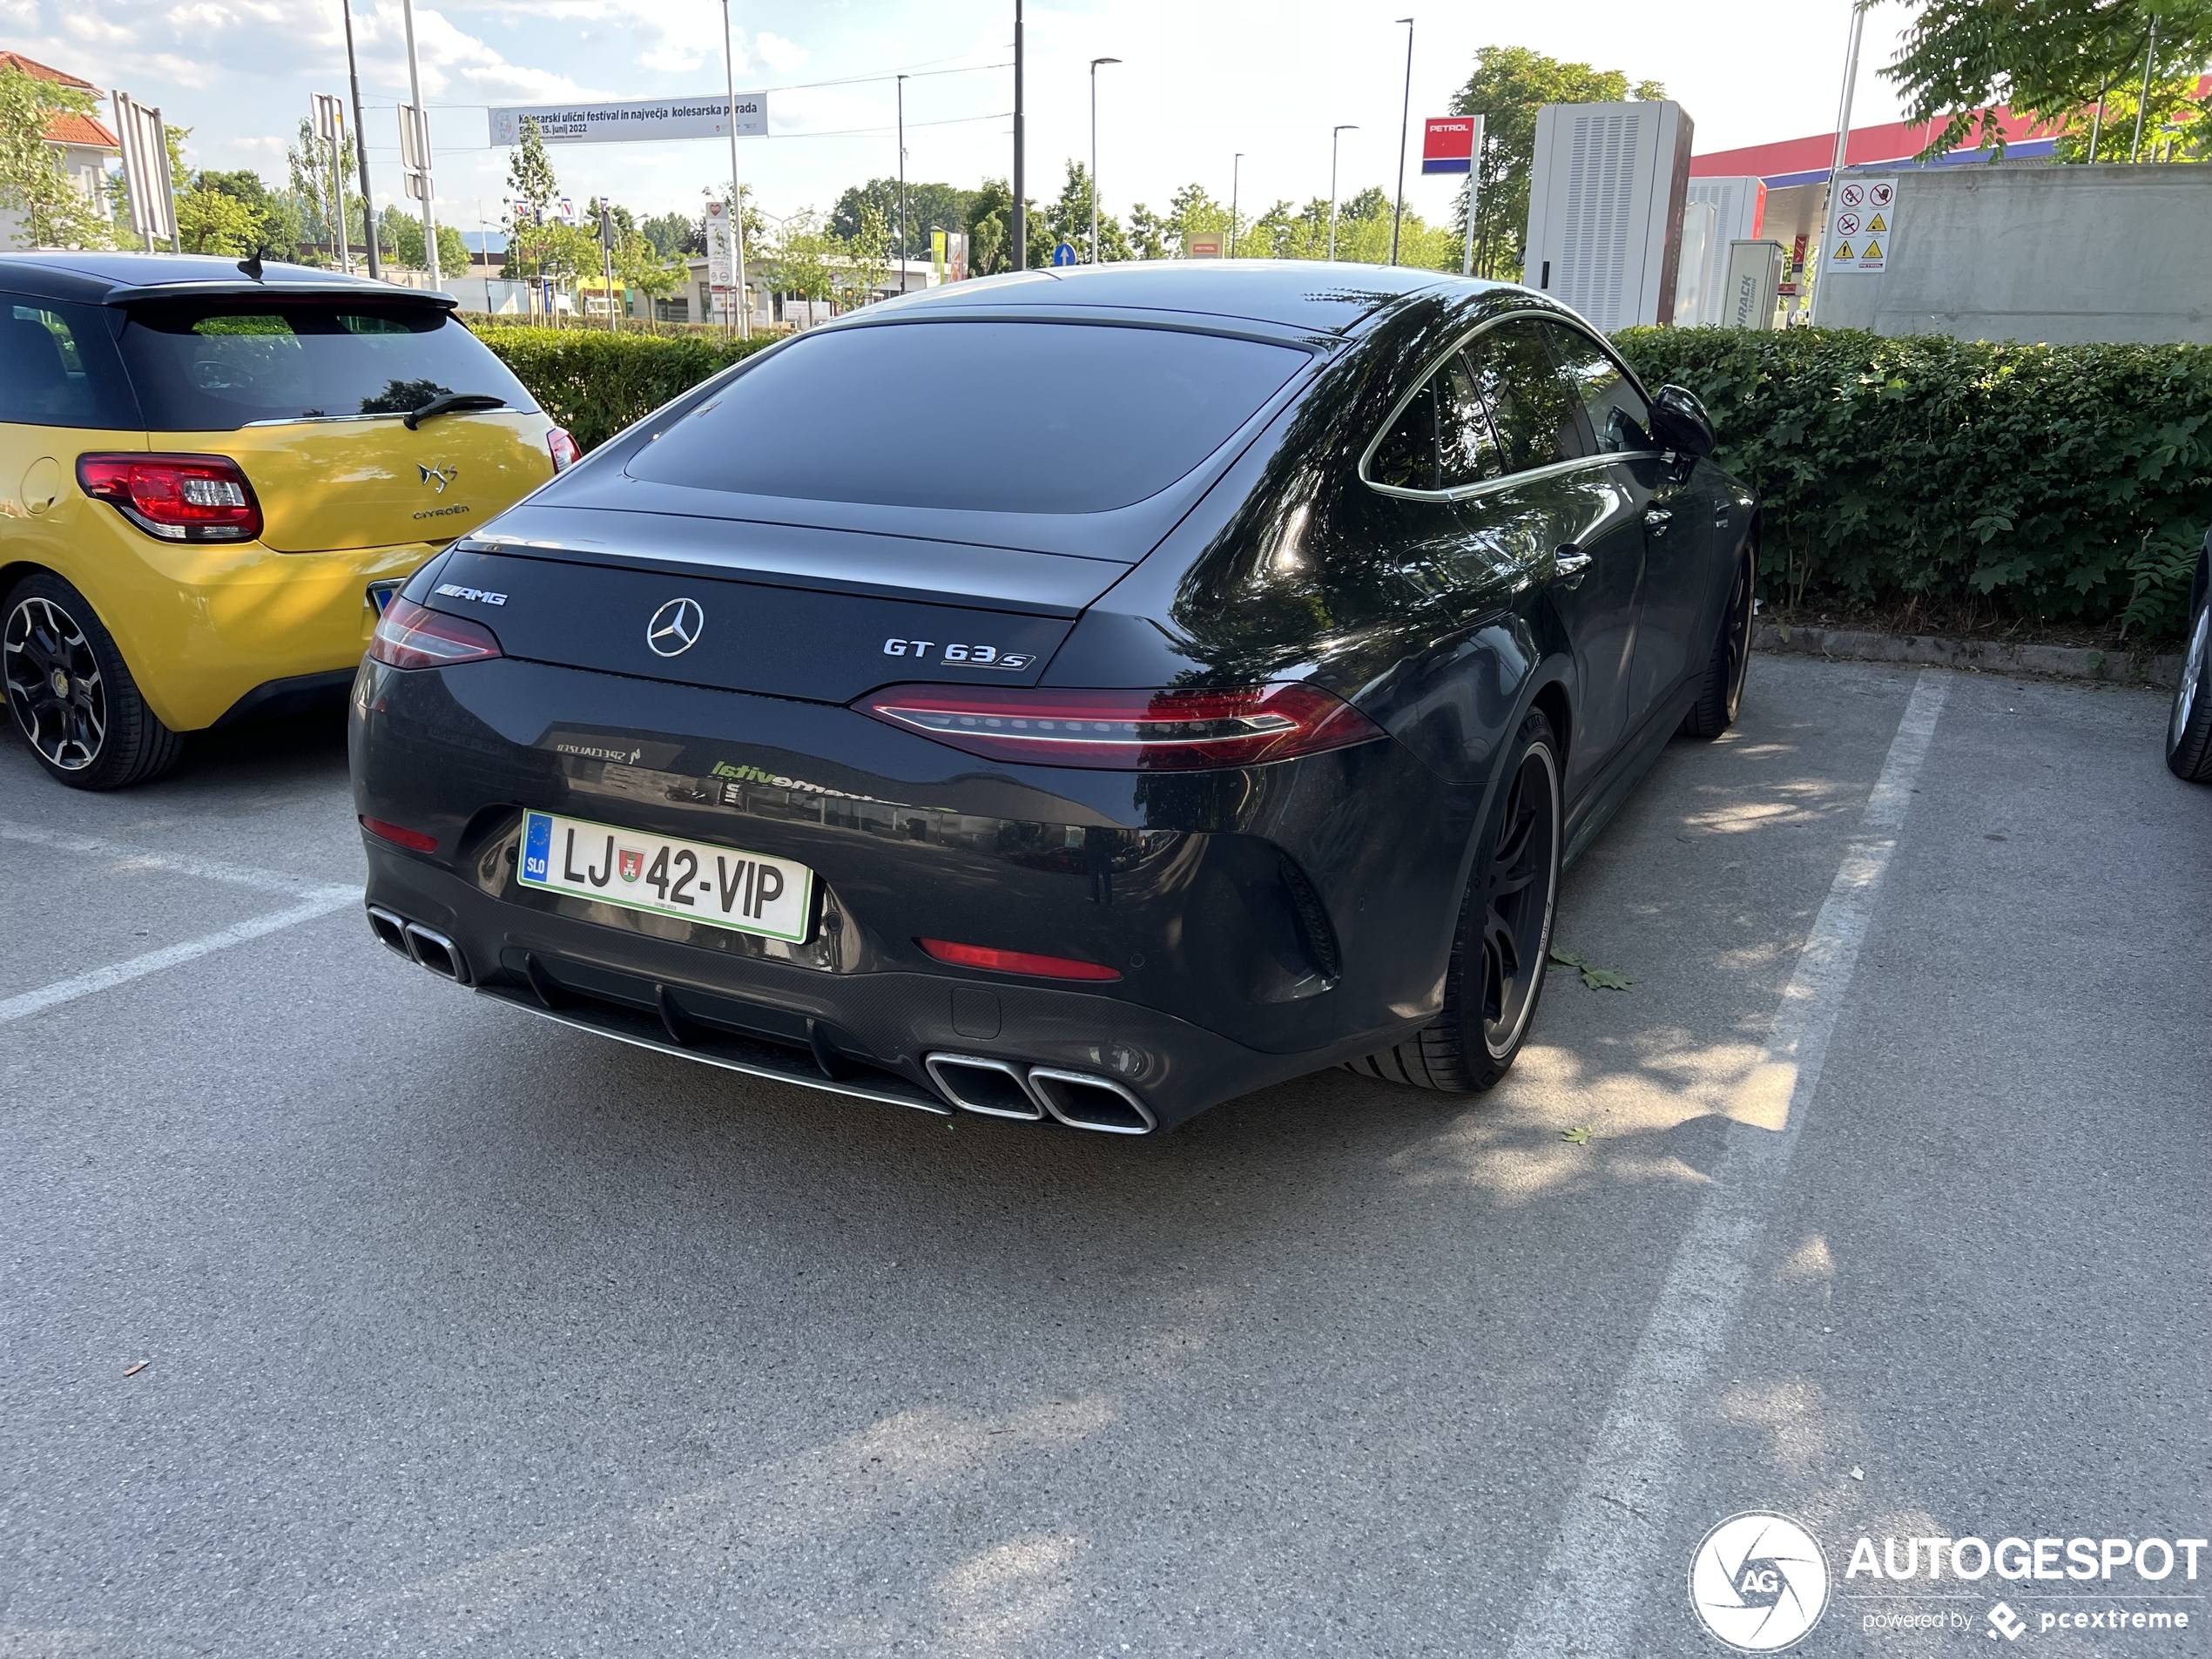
[1508,671,1949,1659]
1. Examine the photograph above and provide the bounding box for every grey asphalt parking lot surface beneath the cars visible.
[0,657,2212,1659]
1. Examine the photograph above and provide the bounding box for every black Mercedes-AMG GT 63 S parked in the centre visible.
[352,261,1758,1135]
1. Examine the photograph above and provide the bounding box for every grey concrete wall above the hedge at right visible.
[1818,164,2212,345]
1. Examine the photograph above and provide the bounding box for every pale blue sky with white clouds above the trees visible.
[0,0,1912,230]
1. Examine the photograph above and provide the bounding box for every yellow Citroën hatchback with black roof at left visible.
[0,253,577,790]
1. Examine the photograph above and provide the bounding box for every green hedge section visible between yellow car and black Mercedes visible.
[475,323,770,449]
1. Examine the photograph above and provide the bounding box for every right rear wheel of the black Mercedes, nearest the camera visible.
[1345,712,1566,1095]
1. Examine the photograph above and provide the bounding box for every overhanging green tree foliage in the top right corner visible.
[1883,0,2212,159]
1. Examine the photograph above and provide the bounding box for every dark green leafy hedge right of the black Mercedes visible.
[1615,327,2212,637]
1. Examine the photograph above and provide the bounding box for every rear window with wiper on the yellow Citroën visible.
[122,300,537,431]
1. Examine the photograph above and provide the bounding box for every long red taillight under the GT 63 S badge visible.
[853,684,1383,772]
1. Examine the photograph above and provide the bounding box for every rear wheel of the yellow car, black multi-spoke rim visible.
[0,570,184,790]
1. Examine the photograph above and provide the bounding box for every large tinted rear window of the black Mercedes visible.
[628,320,1307,513]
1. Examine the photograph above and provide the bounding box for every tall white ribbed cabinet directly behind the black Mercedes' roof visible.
[1522,102,1692,329]
